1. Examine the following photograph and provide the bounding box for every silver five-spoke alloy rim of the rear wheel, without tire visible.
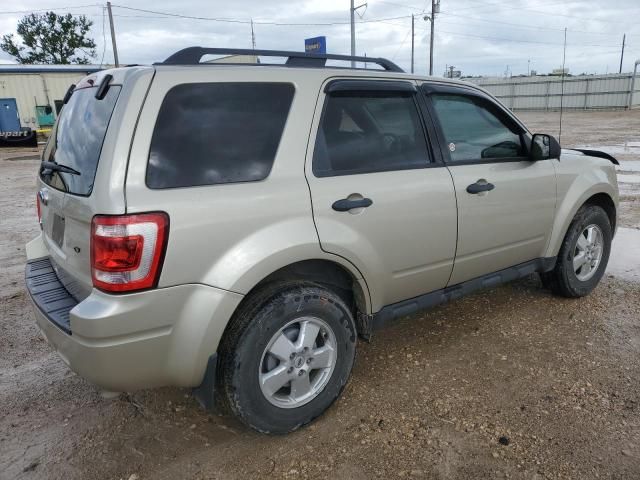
[258,317,338,408]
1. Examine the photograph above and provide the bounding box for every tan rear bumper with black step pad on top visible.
[26,257,242,391]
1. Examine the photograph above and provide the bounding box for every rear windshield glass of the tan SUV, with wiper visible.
[41,86,120,196]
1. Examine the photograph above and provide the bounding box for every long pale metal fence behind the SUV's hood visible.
[467,73,640,110]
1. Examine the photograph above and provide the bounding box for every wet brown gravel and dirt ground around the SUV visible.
[0,111,640,480]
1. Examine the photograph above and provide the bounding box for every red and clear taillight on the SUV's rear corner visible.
[91,213,169,292]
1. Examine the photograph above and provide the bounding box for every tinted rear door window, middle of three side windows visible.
[313,91,430,177]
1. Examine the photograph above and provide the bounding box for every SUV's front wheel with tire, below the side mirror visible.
[540,205,613,298]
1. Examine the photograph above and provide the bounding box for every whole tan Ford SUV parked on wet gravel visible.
[26,47,618,433]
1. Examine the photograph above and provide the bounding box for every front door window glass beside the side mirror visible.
[431,93,527,163]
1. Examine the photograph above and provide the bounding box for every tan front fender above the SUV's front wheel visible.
[545,155,618,257]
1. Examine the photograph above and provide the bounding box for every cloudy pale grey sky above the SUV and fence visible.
[0,0,640,76]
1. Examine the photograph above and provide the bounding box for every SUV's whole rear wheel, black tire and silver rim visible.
[218,282,357,434]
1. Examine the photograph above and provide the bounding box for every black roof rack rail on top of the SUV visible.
[158,47,404,72]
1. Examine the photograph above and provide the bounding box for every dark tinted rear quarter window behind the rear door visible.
[146,83,294,188]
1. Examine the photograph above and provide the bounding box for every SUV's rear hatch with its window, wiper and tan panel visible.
[37,68,153,301]
